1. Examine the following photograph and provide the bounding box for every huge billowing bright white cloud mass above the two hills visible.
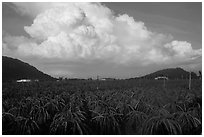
[3,3,202,77]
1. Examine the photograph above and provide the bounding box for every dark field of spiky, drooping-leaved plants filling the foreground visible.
[2,79,202,135]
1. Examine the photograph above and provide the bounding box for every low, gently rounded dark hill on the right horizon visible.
[140,68,199,79]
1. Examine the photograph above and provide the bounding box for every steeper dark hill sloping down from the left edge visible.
[2,56,55,82]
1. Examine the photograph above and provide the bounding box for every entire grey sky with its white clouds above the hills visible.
[2,2,202,78]
